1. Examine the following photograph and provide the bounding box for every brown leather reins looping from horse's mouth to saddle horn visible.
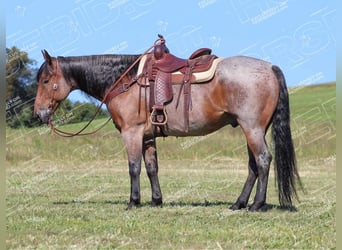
[48,35,164,137]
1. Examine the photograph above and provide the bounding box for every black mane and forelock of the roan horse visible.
[37,55,140,99]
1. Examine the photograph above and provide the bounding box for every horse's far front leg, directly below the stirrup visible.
[143,138,163,207]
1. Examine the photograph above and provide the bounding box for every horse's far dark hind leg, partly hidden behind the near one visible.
[230,146,258,210]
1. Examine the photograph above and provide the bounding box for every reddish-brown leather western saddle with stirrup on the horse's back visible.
[142,35,217,132]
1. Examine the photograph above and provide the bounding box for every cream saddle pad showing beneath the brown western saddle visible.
[137,54,224,84]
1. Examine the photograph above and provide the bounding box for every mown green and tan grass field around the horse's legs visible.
[6,84,336,249]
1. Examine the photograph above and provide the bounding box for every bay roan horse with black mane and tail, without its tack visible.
[34,46,300,211]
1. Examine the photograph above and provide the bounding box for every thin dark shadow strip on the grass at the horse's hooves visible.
[52,200,297,212]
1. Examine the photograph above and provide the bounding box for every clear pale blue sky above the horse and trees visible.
[6,0,337,101]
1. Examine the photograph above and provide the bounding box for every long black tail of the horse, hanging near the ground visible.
[272,65,302,207]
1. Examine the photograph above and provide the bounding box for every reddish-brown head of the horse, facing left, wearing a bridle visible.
[34,50,71,123]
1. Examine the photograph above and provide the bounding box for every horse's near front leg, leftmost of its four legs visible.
[121,128,143,209]
